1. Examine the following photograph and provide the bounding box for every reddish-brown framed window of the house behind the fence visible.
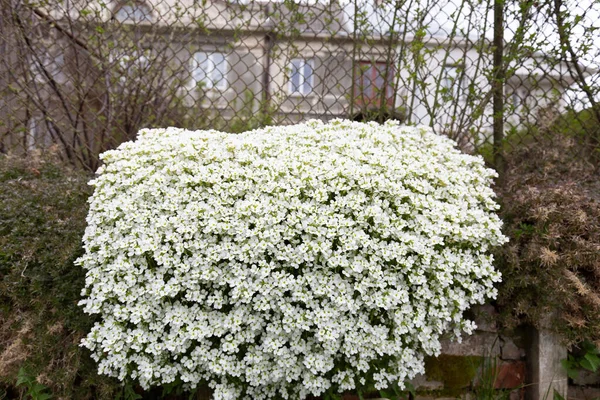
[354,61,394,107]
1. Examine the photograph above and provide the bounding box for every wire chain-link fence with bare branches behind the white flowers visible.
[0,0,600,170]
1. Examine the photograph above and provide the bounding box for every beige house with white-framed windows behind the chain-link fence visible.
[0,0,592,163]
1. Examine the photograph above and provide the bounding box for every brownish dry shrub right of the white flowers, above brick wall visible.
[498,127,600,345]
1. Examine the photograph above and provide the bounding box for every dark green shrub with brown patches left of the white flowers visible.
[0,152,118,399]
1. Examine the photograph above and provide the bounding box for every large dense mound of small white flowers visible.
[78,120,506,399]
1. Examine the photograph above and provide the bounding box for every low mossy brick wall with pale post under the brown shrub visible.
[336,305,600,400]
